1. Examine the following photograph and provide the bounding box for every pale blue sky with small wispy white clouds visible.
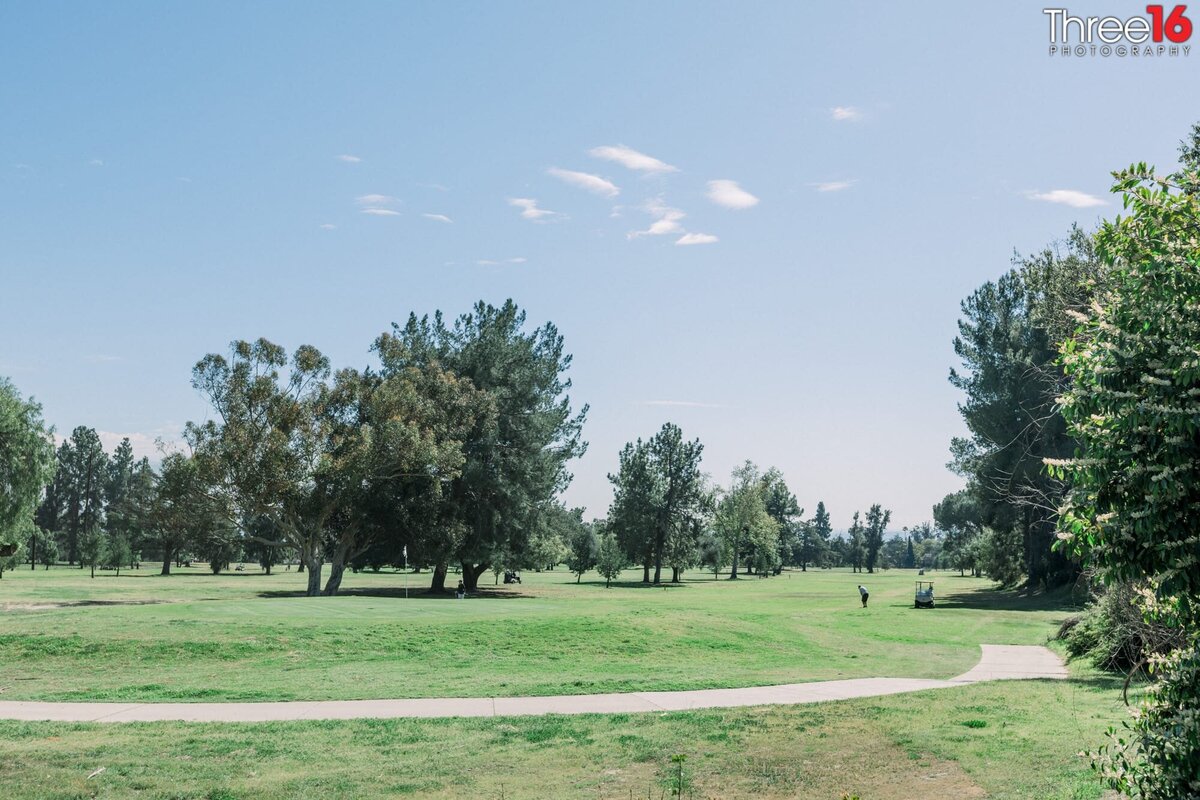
[0,0,1200,528]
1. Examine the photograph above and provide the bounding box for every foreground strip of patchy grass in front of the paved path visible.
[0,673,1123,800]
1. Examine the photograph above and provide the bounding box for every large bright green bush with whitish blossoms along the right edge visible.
[1046,164,1200,800]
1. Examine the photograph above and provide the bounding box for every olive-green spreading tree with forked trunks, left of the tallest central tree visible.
[185,339,473,596]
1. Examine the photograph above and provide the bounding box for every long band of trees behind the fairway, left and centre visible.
[7,301,920,595]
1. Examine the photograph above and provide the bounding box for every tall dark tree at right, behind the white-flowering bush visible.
[950,228,1108,585]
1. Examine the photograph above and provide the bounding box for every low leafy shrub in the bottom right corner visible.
[1092,640,1200,800]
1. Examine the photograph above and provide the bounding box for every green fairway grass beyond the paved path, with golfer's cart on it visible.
[0,567,1080,700]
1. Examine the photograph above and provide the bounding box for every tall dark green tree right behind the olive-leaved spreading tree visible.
[376,300,587,591]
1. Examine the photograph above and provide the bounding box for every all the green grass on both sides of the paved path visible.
[0,567,1126,800]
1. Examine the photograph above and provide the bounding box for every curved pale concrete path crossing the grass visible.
[0,644,1067,722]
